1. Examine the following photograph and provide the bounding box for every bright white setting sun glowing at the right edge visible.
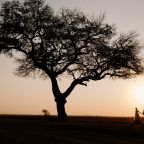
[134,86,144,105]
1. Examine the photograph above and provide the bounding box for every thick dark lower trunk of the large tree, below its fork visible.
[56,97,68,122]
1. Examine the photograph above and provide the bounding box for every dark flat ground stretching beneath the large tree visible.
[0,116,144,144]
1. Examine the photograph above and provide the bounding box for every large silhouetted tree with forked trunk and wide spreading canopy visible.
[0,0,143,121]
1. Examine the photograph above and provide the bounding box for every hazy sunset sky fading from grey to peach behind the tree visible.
[0,0,144,116]
